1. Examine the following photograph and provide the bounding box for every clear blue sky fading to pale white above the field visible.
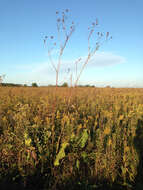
[0,0,143,87]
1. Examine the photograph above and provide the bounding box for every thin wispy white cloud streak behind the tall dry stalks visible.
[32,52,126,75]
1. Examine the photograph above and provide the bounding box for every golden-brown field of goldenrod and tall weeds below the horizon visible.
[0,87,143,190]
